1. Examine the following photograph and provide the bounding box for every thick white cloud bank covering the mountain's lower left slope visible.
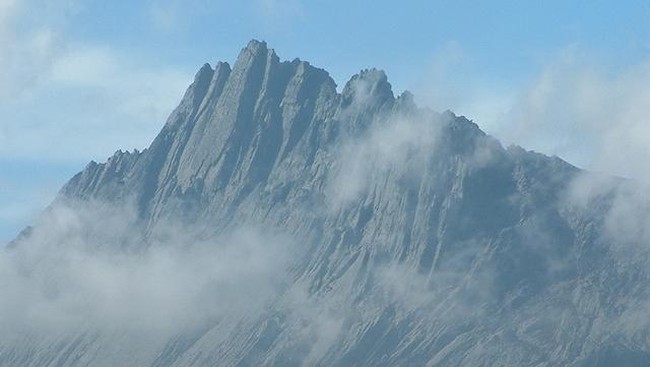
[0,202,295,342]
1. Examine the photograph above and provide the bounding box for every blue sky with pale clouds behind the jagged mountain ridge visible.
[0,0,650,242]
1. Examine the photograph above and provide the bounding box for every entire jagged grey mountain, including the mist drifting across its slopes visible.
[0,41,650,366]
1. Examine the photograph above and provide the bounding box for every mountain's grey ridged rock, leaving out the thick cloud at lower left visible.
[5,41,650,366]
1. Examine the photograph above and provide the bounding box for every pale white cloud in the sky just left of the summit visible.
[0,45,191,161]
